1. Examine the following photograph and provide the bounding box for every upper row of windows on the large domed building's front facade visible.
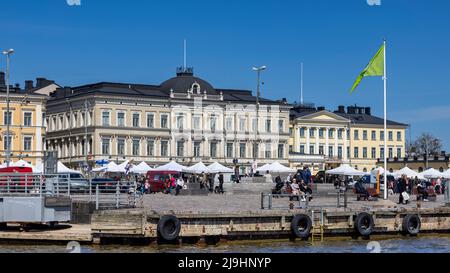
[102,111,284,133]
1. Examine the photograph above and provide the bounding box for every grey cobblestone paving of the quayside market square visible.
[143,185,445,213]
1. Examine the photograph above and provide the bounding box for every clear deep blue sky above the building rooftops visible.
[0,0,450,150]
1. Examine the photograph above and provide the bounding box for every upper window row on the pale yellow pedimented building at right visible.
[300,128,402,141]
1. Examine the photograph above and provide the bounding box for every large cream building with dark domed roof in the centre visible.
[46,68,291,171]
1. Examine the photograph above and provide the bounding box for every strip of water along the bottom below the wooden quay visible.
[0,235,450,253]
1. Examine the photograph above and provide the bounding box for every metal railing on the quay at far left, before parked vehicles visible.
[0,173,143,209]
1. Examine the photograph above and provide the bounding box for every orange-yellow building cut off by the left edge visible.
[0,72,56,166]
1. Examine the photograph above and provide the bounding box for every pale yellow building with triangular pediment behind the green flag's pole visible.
[289,106,408,172]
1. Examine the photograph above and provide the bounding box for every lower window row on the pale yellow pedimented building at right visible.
[300,145,403,159]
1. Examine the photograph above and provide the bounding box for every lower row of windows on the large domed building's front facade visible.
[102,138,285,158]
